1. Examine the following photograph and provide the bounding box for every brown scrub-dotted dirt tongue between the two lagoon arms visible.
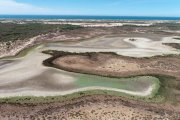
[52,53,180,78]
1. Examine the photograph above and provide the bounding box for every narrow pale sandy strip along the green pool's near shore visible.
[0,83,155,98]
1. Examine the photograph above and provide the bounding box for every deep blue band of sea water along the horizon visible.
[0,15,180,20]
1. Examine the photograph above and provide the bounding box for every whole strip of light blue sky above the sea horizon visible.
[0,0,180,17]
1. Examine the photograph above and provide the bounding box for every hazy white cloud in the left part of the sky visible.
[0,0,56,14]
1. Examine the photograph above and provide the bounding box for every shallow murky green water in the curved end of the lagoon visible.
[75,74,159,91]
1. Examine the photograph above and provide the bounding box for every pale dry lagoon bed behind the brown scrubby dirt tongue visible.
[49,36,180,57]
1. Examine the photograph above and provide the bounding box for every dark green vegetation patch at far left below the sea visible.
[0,23,81,42]
